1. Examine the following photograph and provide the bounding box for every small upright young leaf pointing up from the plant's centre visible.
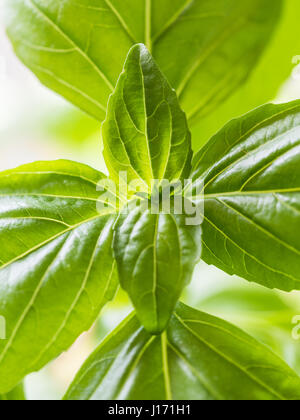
[102,45,192,191]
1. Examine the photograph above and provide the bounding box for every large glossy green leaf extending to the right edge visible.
[193,101,300,291]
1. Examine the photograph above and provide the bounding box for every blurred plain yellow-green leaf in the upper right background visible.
[192,0,300,150]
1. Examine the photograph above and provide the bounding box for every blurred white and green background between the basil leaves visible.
[0,0,300,400]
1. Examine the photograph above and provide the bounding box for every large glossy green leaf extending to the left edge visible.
[0,161,117,393]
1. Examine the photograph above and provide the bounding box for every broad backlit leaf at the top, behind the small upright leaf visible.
[7,0,282,124]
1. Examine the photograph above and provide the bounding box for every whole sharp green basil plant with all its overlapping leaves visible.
[0,0,300,400]
